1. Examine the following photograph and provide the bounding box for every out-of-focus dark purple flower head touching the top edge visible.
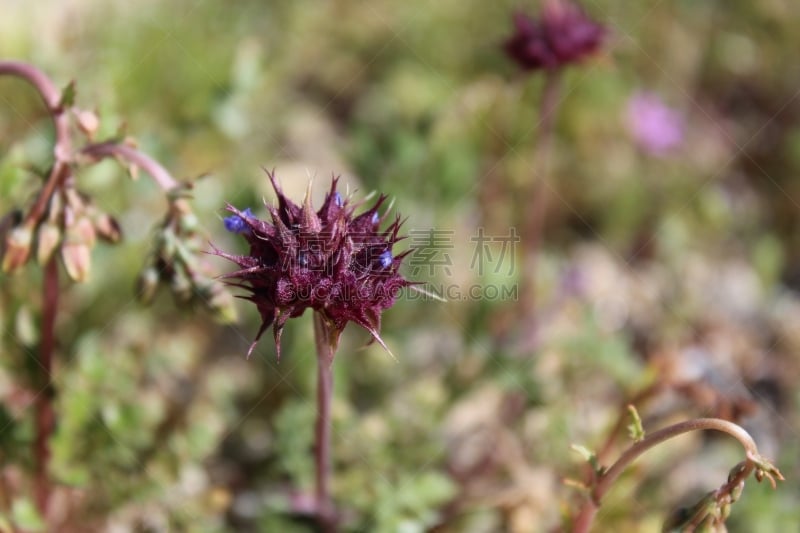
[505,0,606,70]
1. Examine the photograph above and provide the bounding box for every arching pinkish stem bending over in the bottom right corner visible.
[572,418,758,533]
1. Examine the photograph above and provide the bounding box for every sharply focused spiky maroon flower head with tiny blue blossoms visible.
[213,172,415,357]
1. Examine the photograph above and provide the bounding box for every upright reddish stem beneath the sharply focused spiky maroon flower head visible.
[314,312,339,532]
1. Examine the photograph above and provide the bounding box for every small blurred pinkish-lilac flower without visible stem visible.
[627,92,685,157]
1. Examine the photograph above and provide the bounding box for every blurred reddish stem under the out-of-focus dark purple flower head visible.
[520,70,561,344]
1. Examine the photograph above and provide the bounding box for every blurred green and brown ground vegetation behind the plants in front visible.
[0,0,800,532]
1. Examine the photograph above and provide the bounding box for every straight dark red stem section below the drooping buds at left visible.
[34,257,58,515]
